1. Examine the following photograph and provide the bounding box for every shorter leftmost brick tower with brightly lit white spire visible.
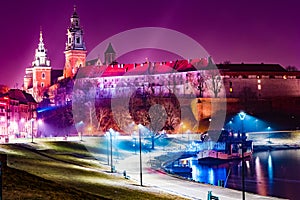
[24,30,51,102]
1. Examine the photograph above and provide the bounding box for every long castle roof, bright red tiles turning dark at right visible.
[78,58,286,77]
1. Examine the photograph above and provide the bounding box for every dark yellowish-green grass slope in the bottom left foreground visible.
[0,142,188,199]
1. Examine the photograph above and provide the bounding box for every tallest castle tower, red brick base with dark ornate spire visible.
[64,6,86,78]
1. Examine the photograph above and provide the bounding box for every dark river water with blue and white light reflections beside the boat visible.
[178,150,300,199]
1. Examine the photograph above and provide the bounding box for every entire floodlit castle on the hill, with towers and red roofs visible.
[23,7,300,105]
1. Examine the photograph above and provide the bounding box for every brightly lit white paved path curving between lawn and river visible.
[115,153,286,200]
